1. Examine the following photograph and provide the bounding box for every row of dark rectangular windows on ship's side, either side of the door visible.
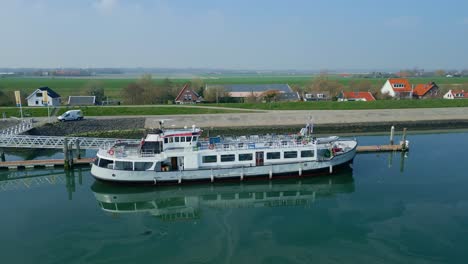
[202,150,314,163]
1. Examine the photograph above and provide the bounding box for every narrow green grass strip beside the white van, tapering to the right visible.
[58,106,254,117]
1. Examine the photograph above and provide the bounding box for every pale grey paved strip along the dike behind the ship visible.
[145,108,468,128]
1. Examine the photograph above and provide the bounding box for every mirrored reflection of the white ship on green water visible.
[91,171,354,221]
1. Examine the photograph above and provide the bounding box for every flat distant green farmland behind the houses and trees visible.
[0,75,468,100]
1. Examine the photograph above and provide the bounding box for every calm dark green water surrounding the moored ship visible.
[0,133,468,264]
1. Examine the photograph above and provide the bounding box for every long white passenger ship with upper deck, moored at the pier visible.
[91,121,357,184]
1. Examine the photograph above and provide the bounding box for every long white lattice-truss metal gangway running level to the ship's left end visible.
[0,135,139,149]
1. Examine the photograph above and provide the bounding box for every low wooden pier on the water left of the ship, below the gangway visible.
[0,158,94,170]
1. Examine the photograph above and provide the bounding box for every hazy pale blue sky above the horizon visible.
[0,0,468,70]
